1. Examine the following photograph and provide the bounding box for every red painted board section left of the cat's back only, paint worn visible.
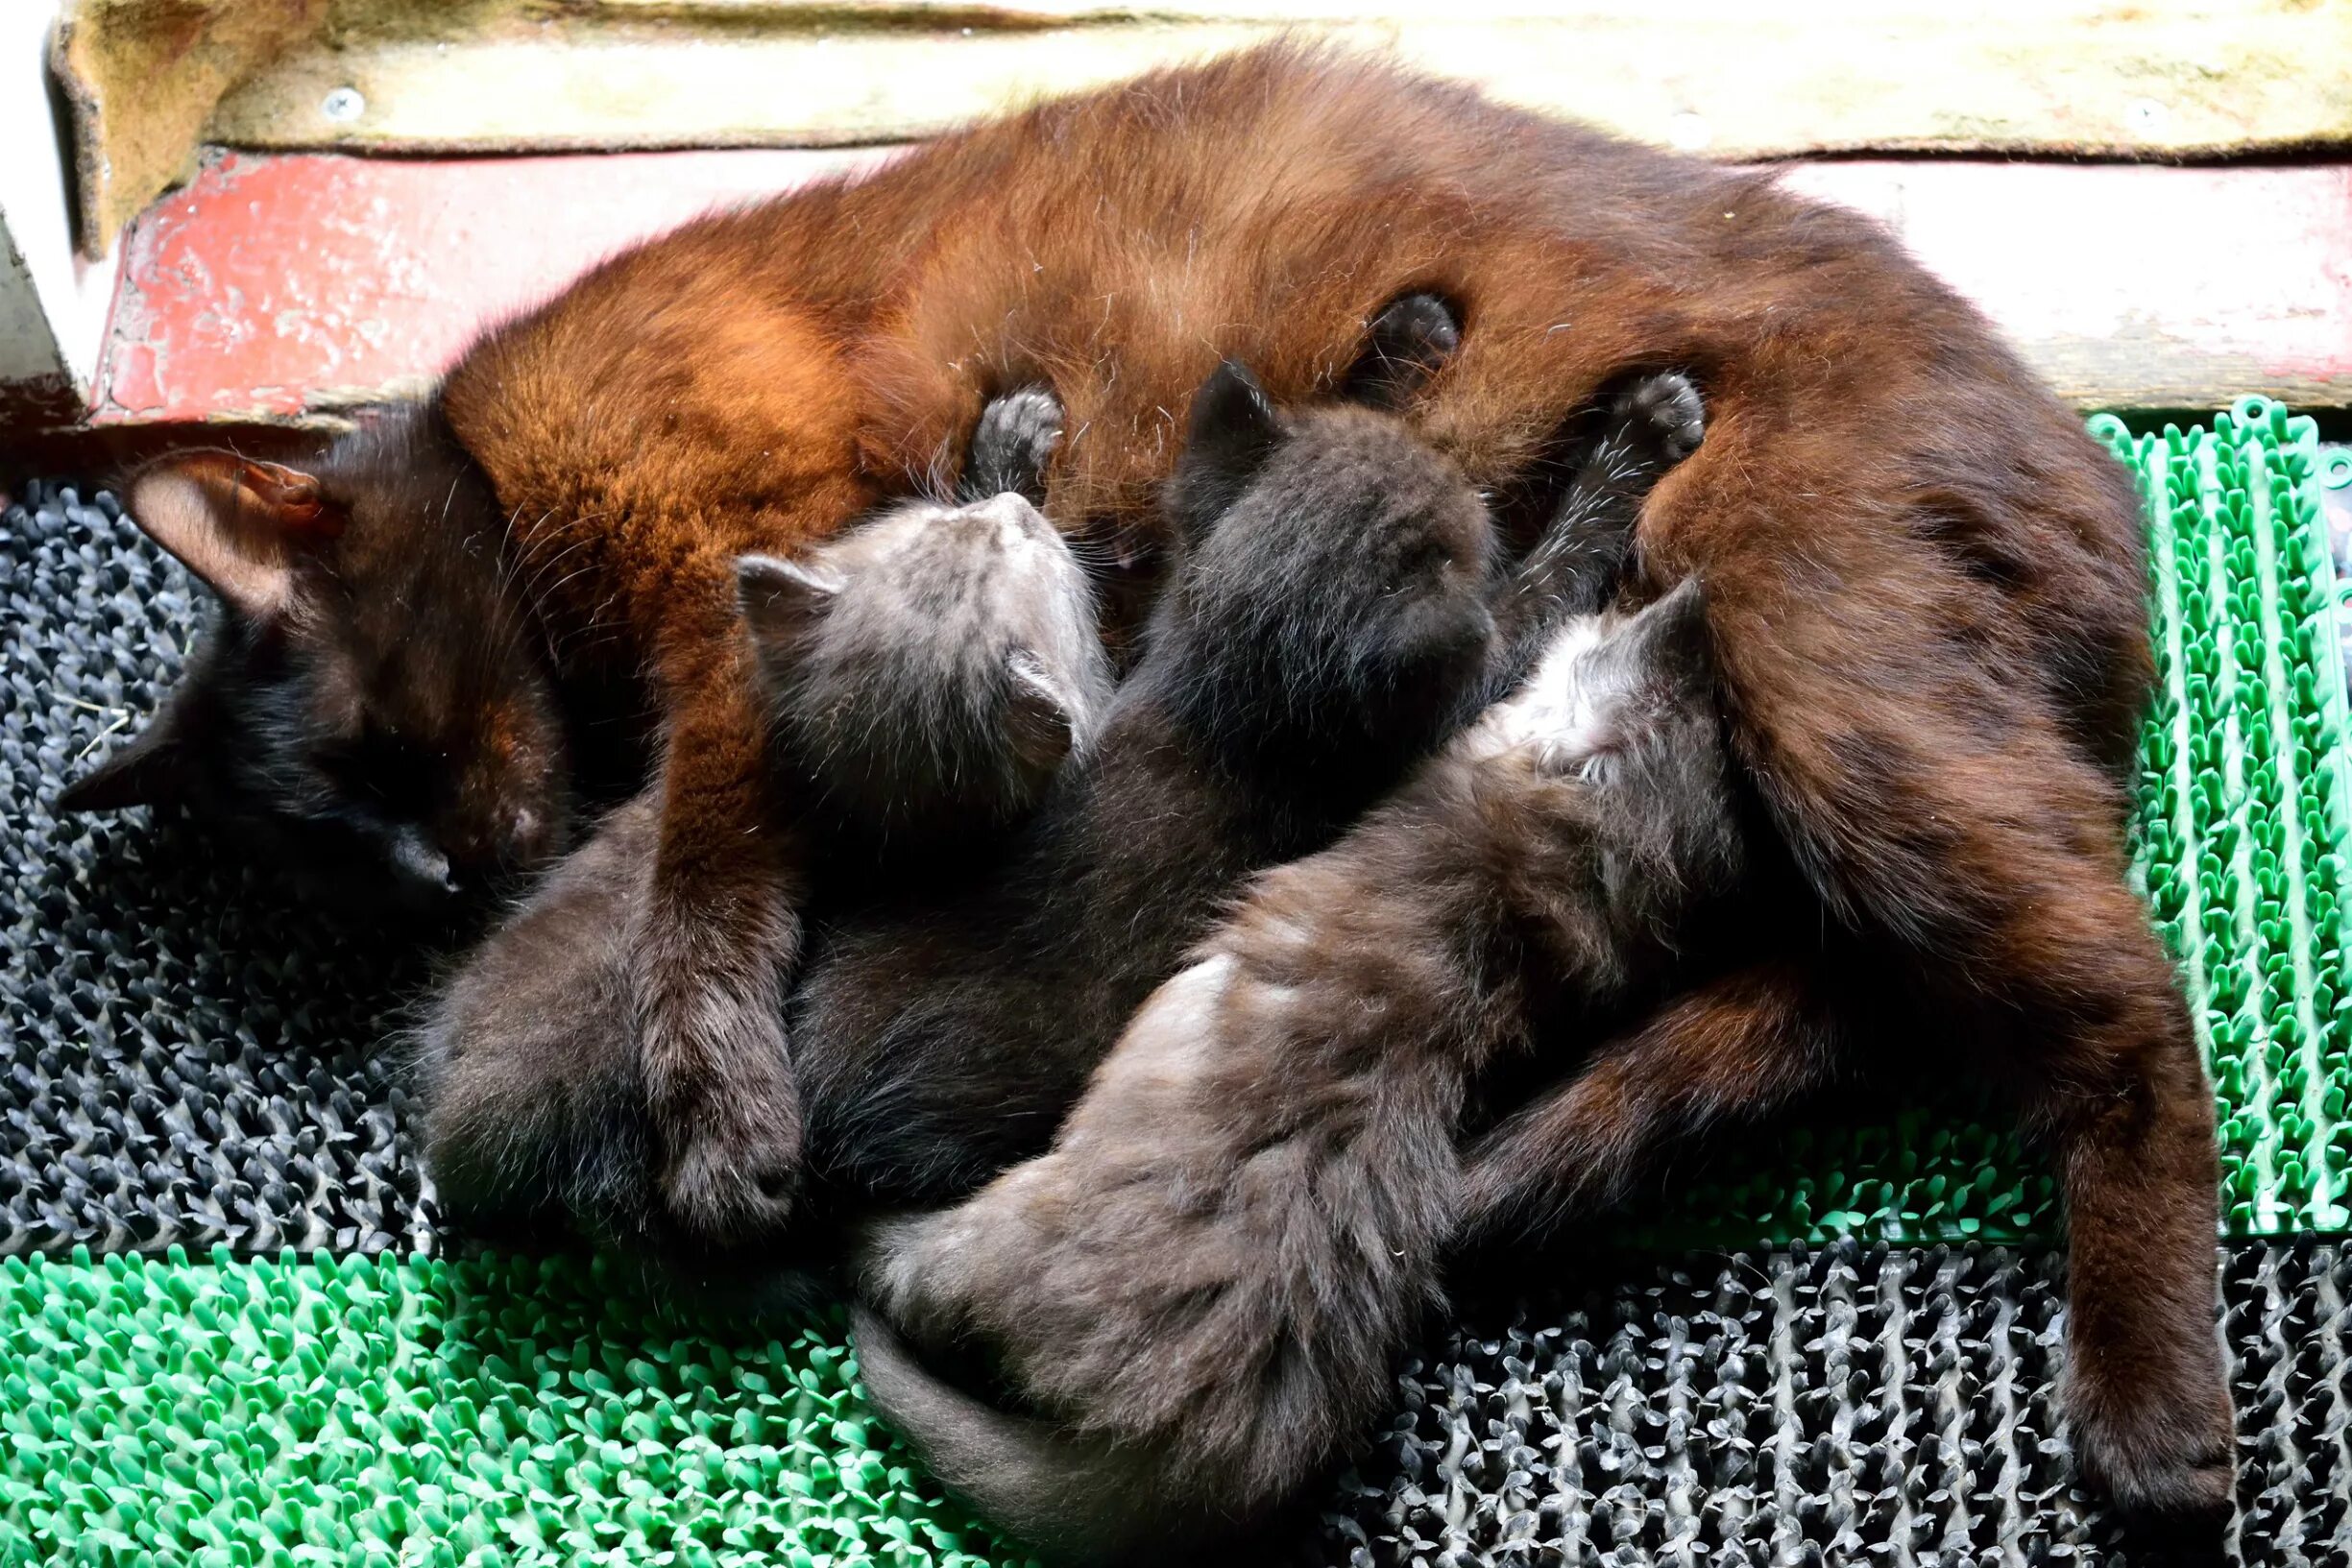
[94,151,882,423]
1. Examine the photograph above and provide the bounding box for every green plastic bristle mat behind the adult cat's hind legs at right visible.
[1618,398,2352,1246]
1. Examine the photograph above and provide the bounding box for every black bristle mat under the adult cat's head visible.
[0,484,428,1255]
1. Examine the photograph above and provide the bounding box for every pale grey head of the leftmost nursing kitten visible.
[737,494,1110,834]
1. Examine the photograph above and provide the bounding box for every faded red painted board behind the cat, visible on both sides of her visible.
[96,151,2352,423]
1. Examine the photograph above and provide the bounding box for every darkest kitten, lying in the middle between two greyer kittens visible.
[790,354,1701,1204]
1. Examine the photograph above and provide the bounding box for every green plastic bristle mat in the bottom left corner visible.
[0,1248,1009,1568]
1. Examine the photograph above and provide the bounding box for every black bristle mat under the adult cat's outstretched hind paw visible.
[1315,1239,2352,1568]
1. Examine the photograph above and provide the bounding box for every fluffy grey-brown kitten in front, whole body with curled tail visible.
[859,583,1743,1563]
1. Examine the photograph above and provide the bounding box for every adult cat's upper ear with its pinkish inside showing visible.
[122,451,351,620]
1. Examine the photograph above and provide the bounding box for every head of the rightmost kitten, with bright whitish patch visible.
[1461,578,1748,901]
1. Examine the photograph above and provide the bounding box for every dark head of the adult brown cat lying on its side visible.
[59,409,570,907]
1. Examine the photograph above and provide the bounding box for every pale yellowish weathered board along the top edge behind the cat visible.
[209,0,2352,157]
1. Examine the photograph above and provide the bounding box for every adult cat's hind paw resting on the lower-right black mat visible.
[2068,1368,2237,1531]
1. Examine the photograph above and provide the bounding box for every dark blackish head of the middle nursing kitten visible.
[1152,362,1493,766]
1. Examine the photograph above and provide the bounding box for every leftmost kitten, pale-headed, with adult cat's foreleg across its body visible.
[416,388,1110,1258]
